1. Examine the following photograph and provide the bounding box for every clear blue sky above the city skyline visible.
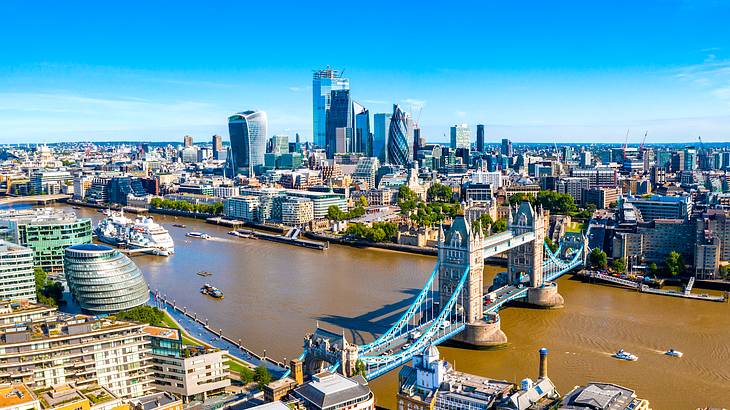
[0,0,730,143]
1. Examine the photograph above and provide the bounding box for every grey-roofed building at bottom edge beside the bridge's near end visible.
[292,372,375,410]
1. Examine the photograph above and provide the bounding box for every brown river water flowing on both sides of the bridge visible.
[51,205,730,409]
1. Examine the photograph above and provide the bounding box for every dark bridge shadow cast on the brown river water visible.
[314,288,426,345]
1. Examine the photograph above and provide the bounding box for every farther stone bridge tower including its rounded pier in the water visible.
[508,201,564,308]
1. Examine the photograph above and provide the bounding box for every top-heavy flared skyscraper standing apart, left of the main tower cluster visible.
[228,111,268,176]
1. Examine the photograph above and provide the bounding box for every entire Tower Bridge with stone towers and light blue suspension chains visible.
[300,202,588,379]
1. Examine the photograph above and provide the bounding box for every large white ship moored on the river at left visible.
[94,212,175,256]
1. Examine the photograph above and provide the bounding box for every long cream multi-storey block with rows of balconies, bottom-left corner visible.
[0,305,151,398]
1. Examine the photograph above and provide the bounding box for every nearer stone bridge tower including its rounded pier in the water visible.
[438,214,507,347]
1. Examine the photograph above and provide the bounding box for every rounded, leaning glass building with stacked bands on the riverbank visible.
[64,244,150,314]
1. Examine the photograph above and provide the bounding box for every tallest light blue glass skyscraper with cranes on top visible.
[312,67,350,147]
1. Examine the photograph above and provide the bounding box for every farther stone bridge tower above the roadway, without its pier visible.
[508,202,545,288]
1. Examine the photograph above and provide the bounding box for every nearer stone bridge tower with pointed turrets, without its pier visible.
[438,215,484,323]
